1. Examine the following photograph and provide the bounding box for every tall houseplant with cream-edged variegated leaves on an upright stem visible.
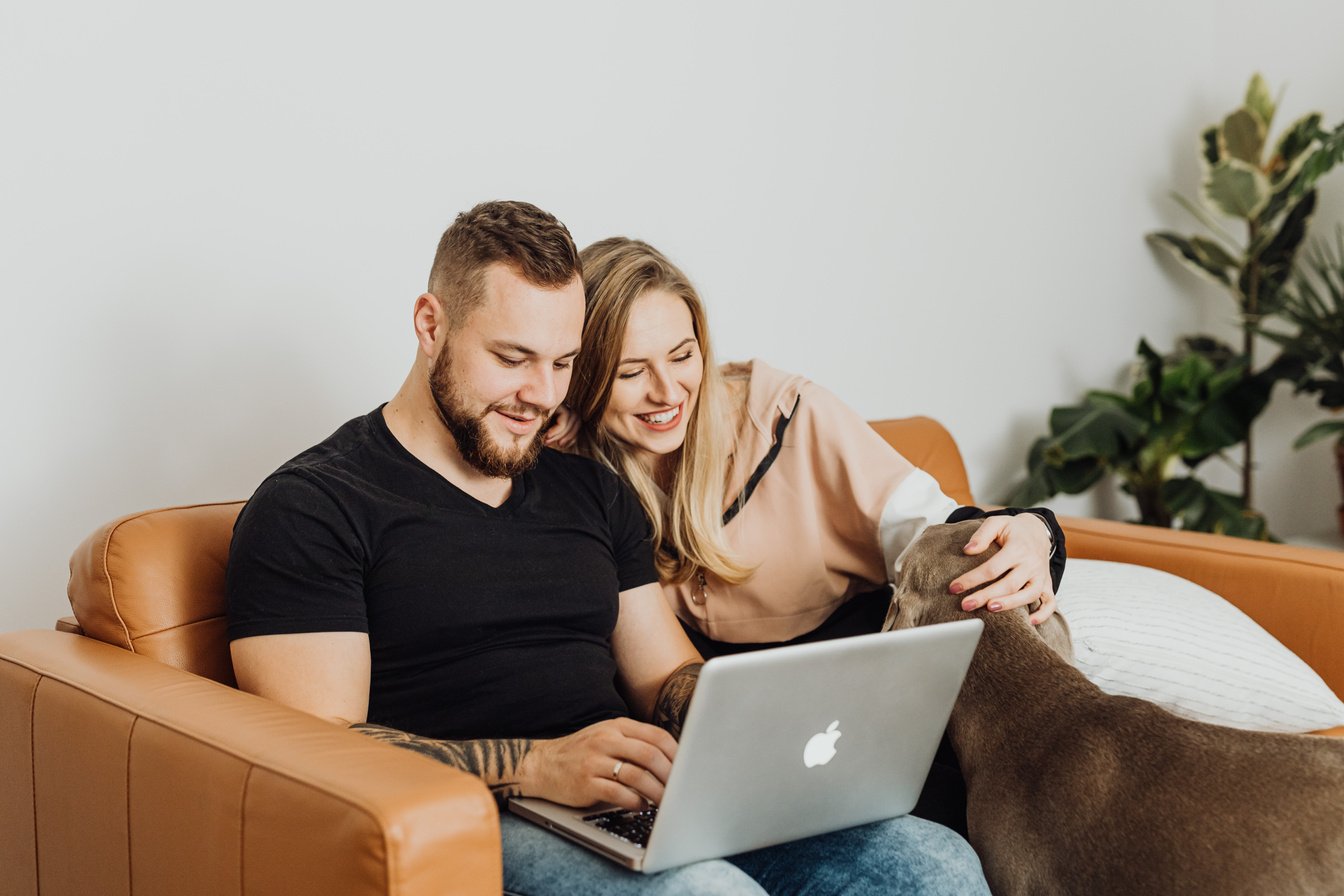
[1149,74,1344,505]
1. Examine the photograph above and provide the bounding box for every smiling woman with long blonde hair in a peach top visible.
[547,236,1064,834]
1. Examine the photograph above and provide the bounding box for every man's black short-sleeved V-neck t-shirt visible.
[227,408,657,739]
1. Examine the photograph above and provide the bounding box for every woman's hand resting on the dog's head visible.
[948,513,1055,625]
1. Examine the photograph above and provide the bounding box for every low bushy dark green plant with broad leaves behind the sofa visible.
[1004,337,1274,539]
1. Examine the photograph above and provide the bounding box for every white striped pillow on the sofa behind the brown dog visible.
[1059,560,1344,732]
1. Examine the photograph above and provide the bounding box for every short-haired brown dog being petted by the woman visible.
[886,521,1344,896]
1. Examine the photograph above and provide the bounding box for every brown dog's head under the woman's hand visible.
[882,520,1073,658]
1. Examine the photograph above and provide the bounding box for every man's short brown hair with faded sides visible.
[429,201,583,325]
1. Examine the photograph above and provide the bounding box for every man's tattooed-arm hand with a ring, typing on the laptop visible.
[519,719,676,809]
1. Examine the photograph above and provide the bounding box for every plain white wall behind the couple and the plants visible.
[0,0,1344,630]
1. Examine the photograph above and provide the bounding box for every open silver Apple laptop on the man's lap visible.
[509,619,984,873]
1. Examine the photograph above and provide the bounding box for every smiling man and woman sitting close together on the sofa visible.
[228,201,1064,895]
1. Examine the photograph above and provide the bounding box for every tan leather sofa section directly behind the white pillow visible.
[1059,517,1344,709]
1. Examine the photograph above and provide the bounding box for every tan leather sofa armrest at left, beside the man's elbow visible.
[0,631,503,896]
